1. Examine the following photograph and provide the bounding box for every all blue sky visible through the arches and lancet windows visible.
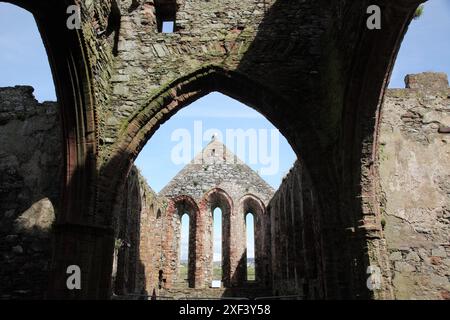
[0,0,450,257]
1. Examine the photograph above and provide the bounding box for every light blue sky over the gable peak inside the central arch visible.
[136,92,296,192]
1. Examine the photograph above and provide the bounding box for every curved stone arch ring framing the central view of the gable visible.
[98,65,299,220]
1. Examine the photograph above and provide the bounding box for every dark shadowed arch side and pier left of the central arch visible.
[1,0,107,299]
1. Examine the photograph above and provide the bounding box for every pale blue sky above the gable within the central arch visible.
[134,92,297,193]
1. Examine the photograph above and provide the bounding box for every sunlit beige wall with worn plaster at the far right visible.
[379,73,450,299]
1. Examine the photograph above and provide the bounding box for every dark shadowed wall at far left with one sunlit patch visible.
[0,86,63,299]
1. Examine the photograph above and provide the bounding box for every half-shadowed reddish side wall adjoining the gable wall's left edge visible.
[112,166,165,296]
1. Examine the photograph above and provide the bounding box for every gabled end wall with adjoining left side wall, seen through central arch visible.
[116,138,275,298]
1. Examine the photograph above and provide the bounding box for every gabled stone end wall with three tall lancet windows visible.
[159,140,274,288]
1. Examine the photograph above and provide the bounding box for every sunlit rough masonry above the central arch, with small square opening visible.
[105,0,269,144]
